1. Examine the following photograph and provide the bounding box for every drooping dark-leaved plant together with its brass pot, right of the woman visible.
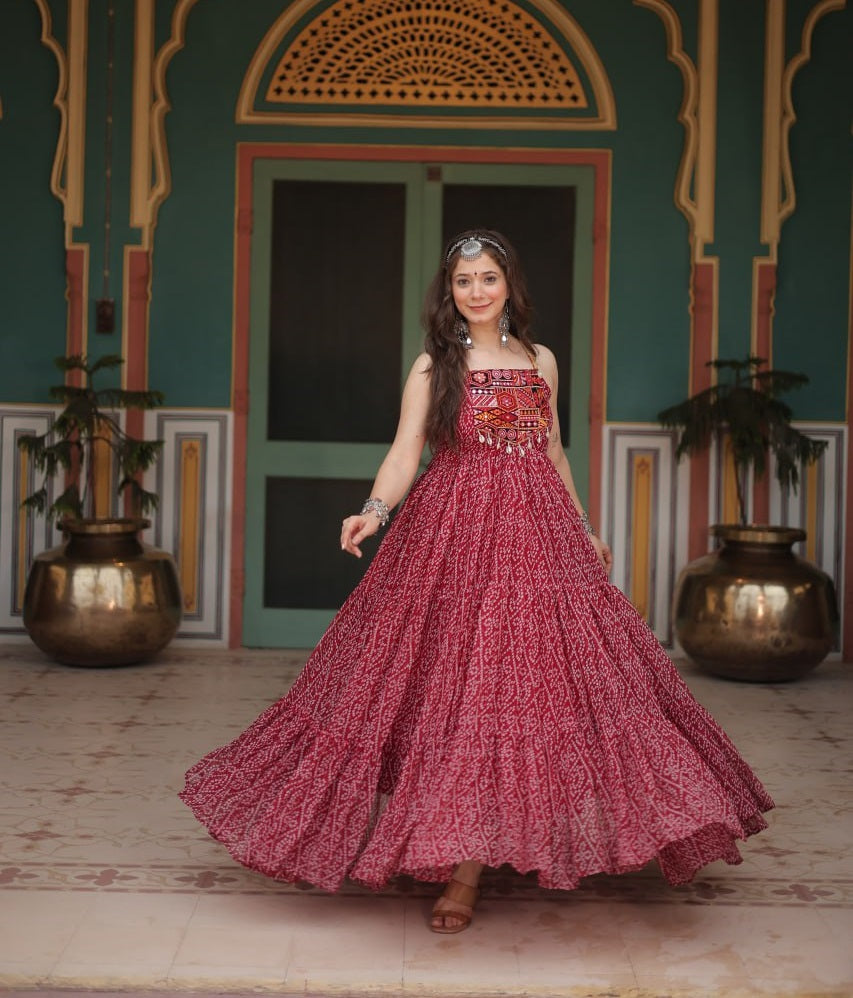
[658,356,838,681]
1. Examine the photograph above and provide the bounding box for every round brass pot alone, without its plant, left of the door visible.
[24,518,181,666]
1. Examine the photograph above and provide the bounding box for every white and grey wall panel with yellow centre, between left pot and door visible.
[145,410,232,644]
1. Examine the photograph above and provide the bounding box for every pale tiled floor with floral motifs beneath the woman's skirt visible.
[0,644,853,998]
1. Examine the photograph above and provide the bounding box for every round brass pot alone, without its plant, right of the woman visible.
[674,525,839,682]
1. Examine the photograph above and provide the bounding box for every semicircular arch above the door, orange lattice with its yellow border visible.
[237,0,616,129]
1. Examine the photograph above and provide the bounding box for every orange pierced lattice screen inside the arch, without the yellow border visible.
[266,0,588,108]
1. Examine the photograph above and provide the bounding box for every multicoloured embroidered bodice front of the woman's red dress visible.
[466,368,552,456]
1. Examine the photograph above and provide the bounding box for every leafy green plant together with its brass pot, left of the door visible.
[19,354,181,666]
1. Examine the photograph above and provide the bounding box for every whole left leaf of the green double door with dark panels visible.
[243,160,422,648]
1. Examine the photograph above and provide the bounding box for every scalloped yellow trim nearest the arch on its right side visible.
[634,0,704,261]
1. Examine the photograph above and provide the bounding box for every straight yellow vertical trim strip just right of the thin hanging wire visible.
[130,0,154,238]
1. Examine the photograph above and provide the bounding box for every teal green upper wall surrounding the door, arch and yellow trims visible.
[0,0,853,421]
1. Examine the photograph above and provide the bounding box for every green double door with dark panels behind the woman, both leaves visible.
[243,160,592,648]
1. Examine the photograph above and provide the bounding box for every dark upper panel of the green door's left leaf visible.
[267,179,406,443]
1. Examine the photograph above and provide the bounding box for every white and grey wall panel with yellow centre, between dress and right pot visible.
[601,424,688,646]
